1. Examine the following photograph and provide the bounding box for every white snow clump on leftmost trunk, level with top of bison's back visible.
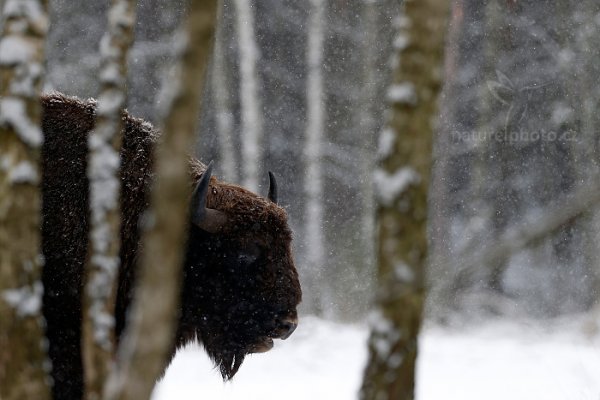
[0,97,43,148]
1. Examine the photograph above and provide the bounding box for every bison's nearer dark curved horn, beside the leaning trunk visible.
[190,161,227,233]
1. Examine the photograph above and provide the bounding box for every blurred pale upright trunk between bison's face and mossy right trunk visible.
[304,0,331,313]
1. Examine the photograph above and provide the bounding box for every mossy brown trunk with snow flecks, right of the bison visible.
[361,0,450,400]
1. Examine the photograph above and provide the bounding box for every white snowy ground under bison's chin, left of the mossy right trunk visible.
[152,317,368,400]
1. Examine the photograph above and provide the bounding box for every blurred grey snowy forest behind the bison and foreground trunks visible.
[46,0,600,320]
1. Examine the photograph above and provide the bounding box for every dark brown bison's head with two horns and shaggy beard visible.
[180,165,301,379]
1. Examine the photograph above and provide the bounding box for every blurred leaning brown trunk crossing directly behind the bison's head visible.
[106,0,217,400]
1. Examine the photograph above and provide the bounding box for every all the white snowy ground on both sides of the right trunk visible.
[152,318,600,400]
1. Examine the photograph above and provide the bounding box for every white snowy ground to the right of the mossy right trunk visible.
[417,320,600,400]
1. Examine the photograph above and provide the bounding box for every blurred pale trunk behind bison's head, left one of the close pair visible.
[211,0,238,182]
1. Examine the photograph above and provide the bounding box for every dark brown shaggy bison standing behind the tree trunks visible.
[41,93,301,399]
